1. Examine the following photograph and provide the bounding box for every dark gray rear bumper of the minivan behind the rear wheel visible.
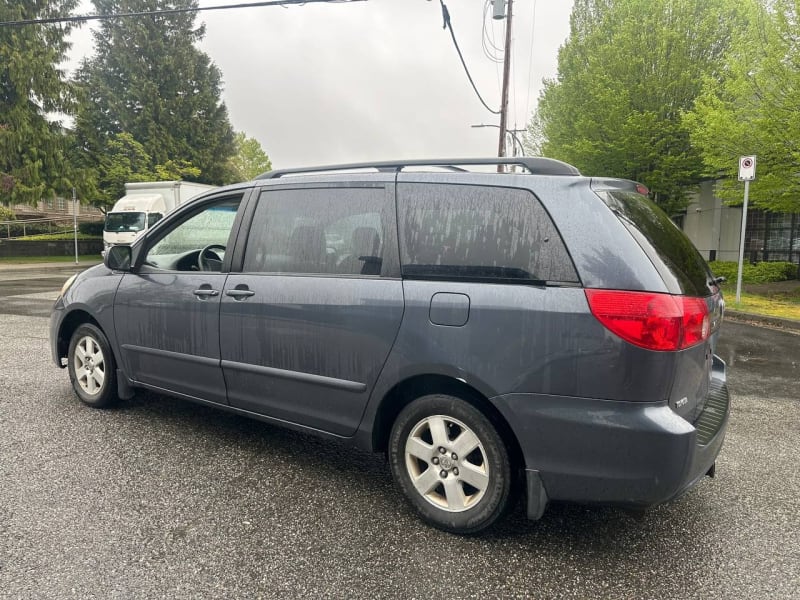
[492,357,729,514]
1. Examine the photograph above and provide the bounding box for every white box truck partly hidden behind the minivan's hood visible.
[103,181,216,253]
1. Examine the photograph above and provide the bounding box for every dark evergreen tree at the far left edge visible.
[0,0,77,204]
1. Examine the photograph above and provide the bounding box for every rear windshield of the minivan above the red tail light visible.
[597,190,712,296]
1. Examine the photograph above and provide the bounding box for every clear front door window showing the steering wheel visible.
[144,197,241,271]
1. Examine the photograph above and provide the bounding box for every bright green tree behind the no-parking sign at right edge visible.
[685,0,800,212]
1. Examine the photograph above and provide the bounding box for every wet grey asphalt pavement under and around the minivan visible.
[0,270,800,599]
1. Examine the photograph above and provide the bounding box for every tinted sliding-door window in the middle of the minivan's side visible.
[244,188,388,275]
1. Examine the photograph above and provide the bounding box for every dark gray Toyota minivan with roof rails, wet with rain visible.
[50,158,729,533]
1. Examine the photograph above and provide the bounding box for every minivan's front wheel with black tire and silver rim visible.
[67,323,119,408]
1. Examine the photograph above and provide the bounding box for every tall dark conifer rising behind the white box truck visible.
[76,0,234,184]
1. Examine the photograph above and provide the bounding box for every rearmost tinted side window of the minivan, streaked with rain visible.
[398,184,578,282]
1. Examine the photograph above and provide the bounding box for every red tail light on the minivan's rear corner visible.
[584,289,711,351]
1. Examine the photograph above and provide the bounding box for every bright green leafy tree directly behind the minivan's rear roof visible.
[528,0,747,213]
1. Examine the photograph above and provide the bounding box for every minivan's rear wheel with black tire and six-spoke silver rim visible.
[388,394,513,534]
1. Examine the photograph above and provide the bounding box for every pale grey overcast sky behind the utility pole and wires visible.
[65,0,572,168]
